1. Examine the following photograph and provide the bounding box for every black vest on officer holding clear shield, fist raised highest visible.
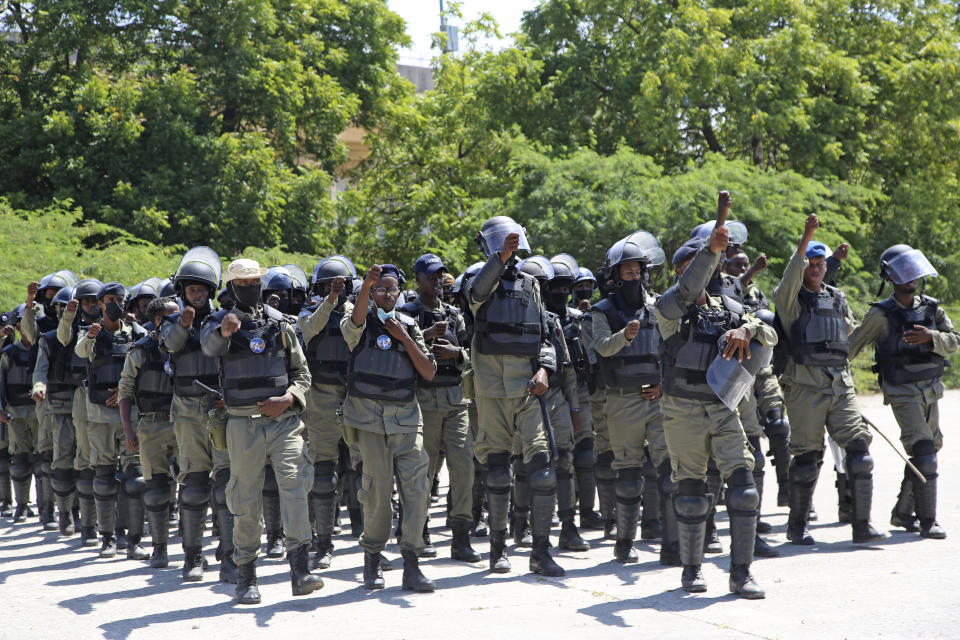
[663,296,744,401]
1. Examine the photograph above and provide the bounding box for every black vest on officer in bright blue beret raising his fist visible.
[789,285,850,367]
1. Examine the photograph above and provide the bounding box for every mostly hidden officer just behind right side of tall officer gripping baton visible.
[515,256,592,551]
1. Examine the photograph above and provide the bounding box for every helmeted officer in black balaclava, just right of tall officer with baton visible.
[591,231,674,562]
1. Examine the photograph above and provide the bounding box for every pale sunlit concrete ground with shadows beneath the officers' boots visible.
[0,392,960,640]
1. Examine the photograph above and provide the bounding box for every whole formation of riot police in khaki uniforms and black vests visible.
[0,198,960,604]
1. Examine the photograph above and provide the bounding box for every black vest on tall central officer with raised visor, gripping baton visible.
[474,271,544,357]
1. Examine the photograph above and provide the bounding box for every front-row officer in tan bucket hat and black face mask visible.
[200,258,323,604]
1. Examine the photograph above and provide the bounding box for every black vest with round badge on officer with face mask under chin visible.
[347,312,417,403]
